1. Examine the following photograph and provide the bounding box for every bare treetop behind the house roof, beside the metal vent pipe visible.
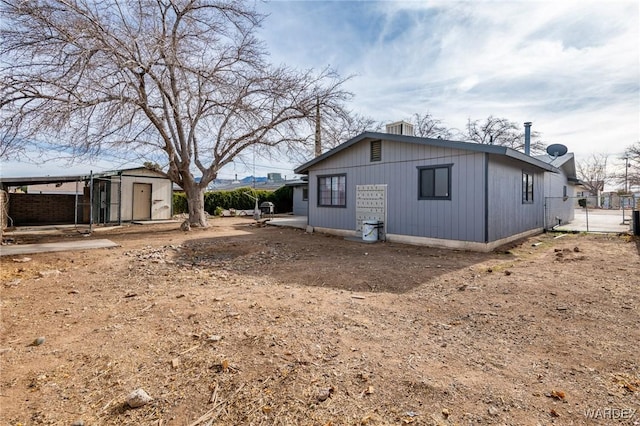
[464,115,545,154]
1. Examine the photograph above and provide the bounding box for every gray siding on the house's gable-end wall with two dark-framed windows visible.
[309,140,485,242]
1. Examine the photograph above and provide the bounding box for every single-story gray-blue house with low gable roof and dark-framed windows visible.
[295,132,575,251]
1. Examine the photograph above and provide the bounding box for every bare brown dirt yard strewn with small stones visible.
[0,218,640,426]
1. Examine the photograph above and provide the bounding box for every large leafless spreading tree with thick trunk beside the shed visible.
[0,0,349,226]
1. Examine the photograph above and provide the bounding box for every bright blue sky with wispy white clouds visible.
[3,0,640,177]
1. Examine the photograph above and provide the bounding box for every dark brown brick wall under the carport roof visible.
[9,193,82,226]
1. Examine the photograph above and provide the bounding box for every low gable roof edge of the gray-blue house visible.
[294,132,558,174]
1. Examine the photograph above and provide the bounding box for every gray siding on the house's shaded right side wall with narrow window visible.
[487,155,544,242]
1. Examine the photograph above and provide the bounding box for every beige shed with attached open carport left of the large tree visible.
[0,167,173,226]
